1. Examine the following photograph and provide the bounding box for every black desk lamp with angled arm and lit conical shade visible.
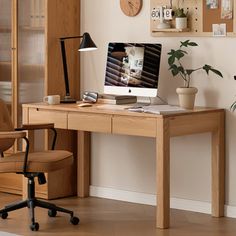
[60,33,97,103]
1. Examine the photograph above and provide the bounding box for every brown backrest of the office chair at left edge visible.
[0,99,15,154]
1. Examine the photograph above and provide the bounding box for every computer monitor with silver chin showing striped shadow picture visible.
[104,43,162,97]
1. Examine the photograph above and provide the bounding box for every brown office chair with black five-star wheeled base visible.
[0,99,79,231]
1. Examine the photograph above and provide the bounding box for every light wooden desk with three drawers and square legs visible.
[23,104,225,228]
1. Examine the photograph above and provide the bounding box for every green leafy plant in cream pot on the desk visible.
[168,40,223,109]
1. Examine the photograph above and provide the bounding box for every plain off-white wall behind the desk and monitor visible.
[81,0,236,206]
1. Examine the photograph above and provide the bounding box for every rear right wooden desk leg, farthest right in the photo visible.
[212,112,225,217]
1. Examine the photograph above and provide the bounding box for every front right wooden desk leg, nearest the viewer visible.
[156,119,170,229]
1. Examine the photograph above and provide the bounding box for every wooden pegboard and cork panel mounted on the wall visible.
[150,0,236,37]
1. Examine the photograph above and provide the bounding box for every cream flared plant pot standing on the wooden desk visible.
[176,87,198,109]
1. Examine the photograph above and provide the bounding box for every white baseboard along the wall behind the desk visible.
[90,186,236,218]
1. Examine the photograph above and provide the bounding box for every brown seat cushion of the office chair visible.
[0,150,73,173]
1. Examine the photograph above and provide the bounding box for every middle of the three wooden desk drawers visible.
[68,112,111,133]
